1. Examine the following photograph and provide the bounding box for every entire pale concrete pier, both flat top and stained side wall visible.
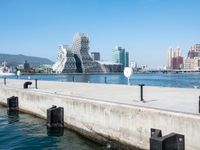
[0,80,200,150]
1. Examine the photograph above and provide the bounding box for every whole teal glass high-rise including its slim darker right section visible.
[112,46,129,68]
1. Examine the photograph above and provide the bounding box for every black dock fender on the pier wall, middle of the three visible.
[47,106,64,128]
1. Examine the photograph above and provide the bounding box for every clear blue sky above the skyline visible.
[0,0,200,67]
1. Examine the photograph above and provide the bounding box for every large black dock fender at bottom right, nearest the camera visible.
[150,129,185,150]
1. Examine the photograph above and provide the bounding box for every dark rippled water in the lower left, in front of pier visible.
[0,105,106,150]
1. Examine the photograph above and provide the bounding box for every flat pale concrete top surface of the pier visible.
[0,79,200,114]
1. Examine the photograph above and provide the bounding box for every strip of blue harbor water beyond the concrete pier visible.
[0,72,200,88]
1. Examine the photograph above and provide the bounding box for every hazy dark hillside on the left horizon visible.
[0,54,53,66]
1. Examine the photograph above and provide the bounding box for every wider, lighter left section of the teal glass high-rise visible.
[112,46,126,67]
